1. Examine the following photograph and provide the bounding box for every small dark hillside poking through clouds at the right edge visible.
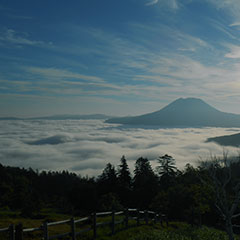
[206,133,240,147]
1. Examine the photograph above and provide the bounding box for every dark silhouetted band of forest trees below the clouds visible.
[0,154,240,238]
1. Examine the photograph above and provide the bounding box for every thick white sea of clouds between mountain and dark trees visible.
[0,120,240,176]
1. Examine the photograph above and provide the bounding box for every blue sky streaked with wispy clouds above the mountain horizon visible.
[0,0,240,117]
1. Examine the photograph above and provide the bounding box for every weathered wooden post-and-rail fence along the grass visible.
[0,209,168,240]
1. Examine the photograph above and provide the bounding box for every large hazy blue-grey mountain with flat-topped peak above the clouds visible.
[106,98,240,127]
